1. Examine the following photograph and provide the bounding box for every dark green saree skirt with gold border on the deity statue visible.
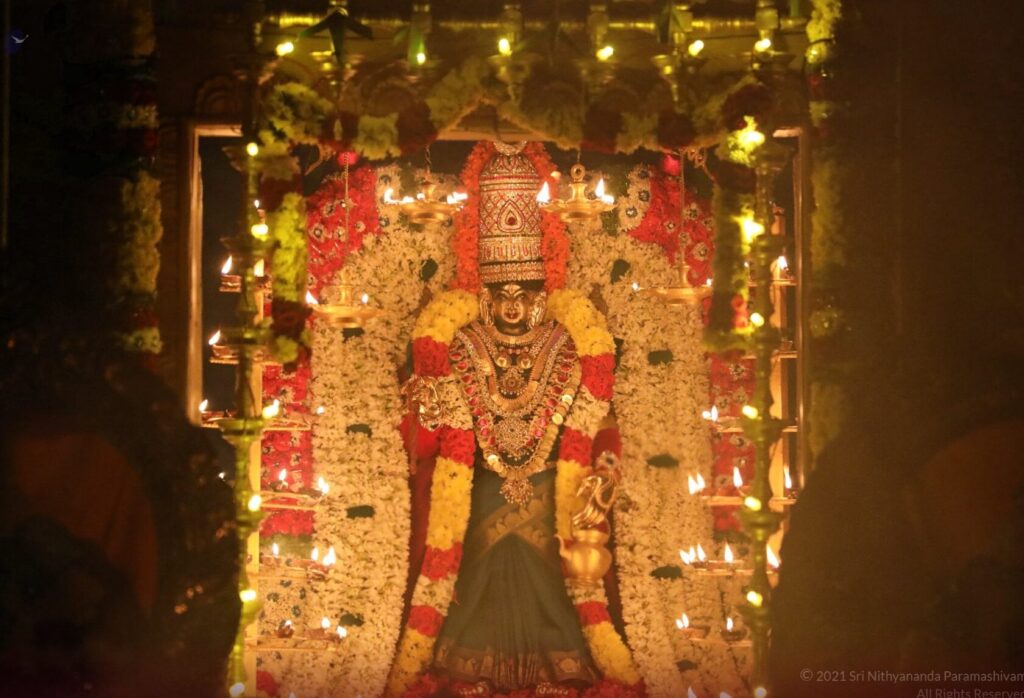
[434,462,599,691]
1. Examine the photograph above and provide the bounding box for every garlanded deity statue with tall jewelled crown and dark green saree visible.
[389,143,640,696]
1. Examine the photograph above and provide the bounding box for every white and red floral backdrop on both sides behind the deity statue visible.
[251,149,753,697]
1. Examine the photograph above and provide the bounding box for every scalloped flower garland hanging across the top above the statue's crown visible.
[258,57,782,160]
